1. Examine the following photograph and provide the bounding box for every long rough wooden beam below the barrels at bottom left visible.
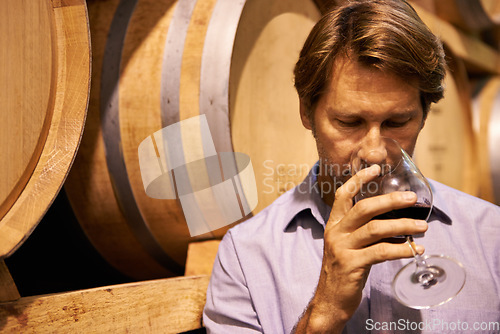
[0,276,209,333]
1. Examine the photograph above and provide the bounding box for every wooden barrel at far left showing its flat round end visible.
[0,0,90,258]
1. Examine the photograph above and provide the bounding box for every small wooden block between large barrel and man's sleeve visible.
[185,240,220,276]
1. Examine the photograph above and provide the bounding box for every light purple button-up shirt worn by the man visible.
[203,165,500,334]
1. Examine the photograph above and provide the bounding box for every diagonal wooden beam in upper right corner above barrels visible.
[412,2,500,74]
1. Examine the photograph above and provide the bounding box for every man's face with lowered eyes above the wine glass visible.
[301,59,424,196]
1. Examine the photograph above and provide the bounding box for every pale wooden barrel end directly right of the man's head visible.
[414,48,479,195]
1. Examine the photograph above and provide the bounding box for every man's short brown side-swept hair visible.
[294,0,446,119]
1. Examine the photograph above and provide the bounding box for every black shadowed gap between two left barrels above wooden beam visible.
[5,188,133,297]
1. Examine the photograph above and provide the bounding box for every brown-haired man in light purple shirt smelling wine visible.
[204,0,500,334]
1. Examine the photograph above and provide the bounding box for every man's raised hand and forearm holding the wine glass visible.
[296,165,427,333]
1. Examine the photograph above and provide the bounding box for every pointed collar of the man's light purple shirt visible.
[280,162,452,230]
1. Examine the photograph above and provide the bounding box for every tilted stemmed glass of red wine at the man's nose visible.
[351,137,465,309]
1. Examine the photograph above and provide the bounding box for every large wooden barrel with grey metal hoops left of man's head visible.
[65,0,320,279]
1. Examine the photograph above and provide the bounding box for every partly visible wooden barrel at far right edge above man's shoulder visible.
[473,76,500,205]
